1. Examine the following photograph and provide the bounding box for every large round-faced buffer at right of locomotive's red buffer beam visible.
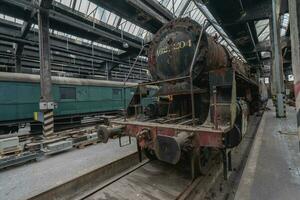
[154,132,191,164]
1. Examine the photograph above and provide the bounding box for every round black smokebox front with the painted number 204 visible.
[149,19,201,80]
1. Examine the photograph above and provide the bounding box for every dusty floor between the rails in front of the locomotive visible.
[88,160,191,200]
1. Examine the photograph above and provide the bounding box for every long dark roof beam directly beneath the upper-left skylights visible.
[0,0,142,53]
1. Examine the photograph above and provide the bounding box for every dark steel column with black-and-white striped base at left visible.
[38,0,54,137]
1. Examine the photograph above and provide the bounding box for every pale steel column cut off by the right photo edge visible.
[289,0,300,150]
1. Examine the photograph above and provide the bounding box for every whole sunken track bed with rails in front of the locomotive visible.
[30,114,258,200]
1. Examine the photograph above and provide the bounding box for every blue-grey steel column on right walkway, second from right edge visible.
[270,0,286,117]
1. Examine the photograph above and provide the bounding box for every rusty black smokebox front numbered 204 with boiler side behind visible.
[148,18,230,80]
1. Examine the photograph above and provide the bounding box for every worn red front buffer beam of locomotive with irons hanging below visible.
[99,119,232,179]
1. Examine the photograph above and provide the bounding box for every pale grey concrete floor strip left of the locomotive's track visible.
[0,138,136,200]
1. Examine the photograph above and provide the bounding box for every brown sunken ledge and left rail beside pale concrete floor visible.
[28,152,145,200]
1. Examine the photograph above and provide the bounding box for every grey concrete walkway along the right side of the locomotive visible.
[235,101,300,200]
